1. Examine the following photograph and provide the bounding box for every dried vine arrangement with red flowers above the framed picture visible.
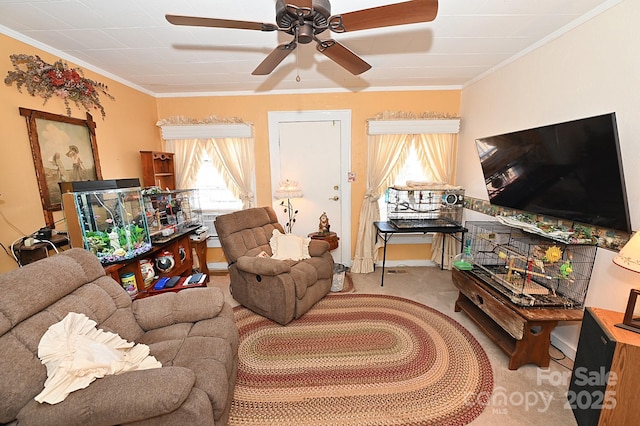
[4,54,115,119]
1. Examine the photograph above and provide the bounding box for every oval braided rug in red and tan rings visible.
[229,294,493,425]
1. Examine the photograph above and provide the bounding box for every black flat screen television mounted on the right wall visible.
[476,113,631,232]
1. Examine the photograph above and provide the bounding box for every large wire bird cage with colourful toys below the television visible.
[465,221,596,308]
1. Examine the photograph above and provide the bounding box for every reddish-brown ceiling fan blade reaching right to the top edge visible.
[329,0,438,33]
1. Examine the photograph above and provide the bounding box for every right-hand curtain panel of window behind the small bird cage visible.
[415,133,460,269]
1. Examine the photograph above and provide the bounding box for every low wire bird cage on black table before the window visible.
[385,186,464,225]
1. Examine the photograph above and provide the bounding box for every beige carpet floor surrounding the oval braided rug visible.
[209,267,576,426]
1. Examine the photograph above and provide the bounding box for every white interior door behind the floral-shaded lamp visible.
[269,111,351,265]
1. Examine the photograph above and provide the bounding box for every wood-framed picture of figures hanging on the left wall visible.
[20,108,102,228]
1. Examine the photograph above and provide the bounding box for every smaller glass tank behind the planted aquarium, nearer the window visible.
[142,187,203,243]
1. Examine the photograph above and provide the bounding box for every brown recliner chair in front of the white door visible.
[215,207,333,325]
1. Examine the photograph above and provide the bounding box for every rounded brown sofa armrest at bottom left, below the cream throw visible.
[18,367,196,425]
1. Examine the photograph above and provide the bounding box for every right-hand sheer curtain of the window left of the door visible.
[207,138,256,209]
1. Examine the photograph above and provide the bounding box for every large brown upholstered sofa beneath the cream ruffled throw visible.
[0,249,238,426]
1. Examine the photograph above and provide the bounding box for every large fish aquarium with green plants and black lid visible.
[61,179,152,265]
